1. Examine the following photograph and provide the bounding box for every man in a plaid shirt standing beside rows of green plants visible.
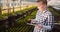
[31,0,54,32]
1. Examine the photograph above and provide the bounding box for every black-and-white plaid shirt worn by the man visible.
[34,10,54,32]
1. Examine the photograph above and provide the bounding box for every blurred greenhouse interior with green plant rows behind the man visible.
[0,0,60,32]
